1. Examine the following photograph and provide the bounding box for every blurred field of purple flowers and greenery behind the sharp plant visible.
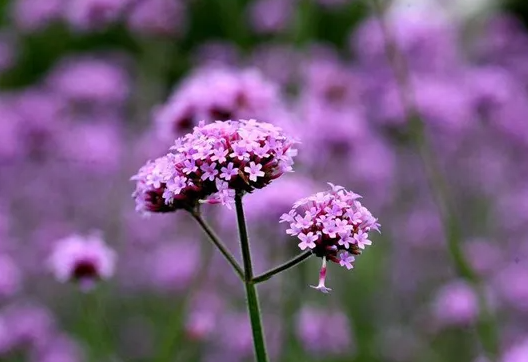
[0,0,528,362]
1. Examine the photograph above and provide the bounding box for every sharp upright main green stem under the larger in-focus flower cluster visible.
[235,193,268,362]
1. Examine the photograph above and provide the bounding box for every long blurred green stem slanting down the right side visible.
[371,0,498,361]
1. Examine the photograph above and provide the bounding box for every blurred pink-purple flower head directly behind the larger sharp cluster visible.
[154,67,286,138]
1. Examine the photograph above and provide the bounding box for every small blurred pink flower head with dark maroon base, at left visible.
[48,234,116,289]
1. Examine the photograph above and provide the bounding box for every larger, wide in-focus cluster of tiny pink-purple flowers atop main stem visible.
[132,119,297,212]
